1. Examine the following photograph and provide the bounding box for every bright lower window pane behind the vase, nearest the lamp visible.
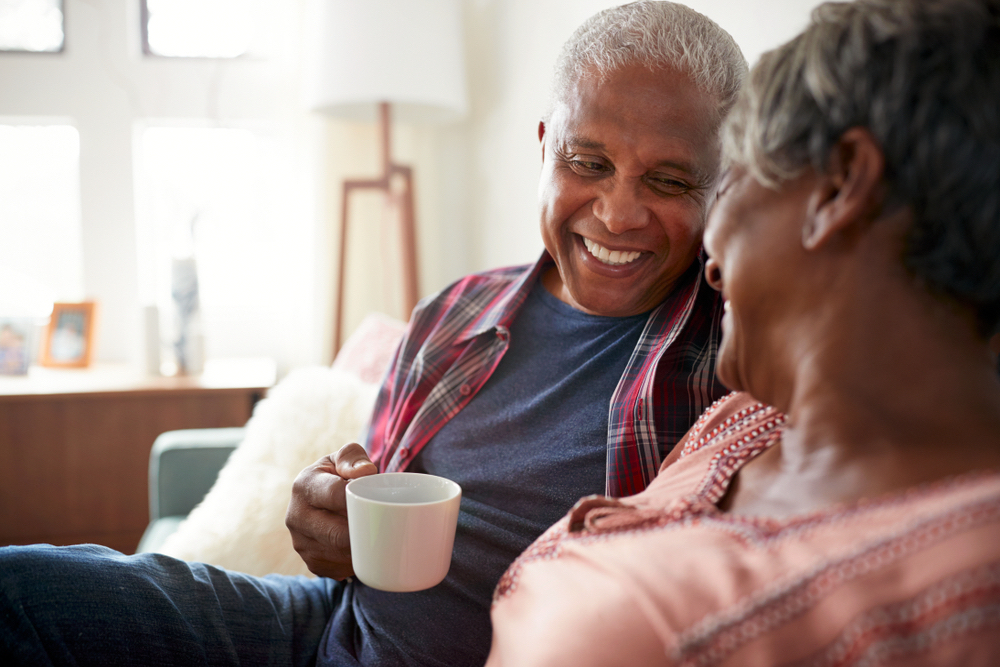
[137,127,311,366]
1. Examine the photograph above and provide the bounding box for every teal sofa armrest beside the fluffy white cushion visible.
[149,428,244,522]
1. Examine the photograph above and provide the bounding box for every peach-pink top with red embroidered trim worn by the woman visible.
[487,394,1000,667]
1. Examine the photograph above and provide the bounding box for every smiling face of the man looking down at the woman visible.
[539,66,719,317]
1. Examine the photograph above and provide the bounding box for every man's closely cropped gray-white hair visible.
[545,0,747,120]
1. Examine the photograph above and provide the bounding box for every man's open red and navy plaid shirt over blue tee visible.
[365,253,727,497]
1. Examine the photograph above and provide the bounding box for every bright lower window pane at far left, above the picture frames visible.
[0,125,84,315]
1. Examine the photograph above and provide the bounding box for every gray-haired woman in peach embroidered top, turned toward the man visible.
[488,0,1000,667]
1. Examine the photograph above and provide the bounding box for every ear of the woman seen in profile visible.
[802,127,885,250]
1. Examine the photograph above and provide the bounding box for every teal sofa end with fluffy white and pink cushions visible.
[137,314,405,576]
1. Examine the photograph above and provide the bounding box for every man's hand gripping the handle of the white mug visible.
[285,443,378,579]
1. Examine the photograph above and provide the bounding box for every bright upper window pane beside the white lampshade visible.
[143,0,260,58]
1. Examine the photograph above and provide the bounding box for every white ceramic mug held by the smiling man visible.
[347,472,462,592]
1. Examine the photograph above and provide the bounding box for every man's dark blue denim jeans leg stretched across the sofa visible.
[0,545,342,667]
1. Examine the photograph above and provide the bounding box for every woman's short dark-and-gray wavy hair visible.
[723,0,1000,334]
